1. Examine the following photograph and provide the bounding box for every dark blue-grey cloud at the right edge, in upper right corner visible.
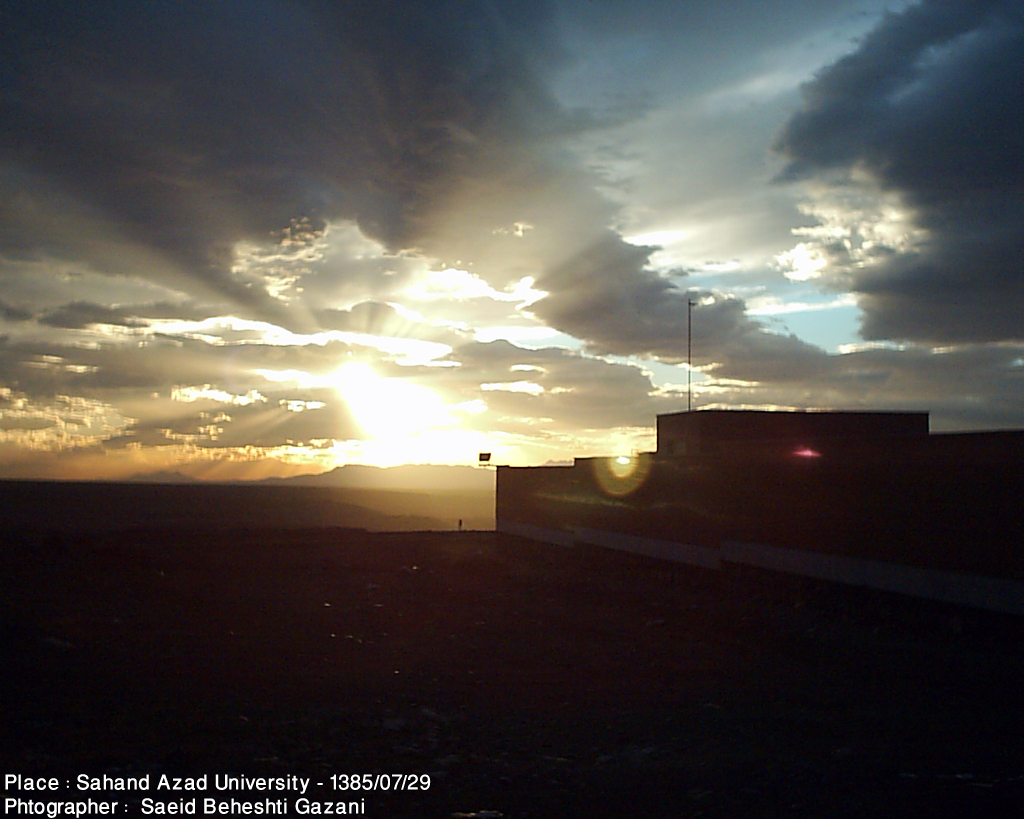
[777,0,1024,342]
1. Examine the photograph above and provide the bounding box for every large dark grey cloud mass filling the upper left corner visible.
[0,0,553,319]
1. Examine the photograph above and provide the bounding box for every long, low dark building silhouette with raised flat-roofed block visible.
[496,410,1024,614]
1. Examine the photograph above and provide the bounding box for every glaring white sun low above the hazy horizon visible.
[333,361,452,439]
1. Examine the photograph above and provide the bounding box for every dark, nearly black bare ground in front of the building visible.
[0,530,1024,819]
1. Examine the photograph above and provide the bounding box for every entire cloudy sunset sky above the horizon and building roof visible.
[0,0,1024,480]
